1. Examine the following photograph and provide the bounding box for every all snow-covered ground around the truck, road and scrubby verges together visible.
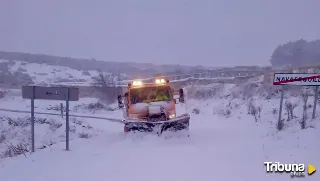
[0,82,320,181]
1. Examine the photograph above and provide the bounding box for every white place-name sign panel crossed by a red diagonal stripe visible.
[273,73,320,86]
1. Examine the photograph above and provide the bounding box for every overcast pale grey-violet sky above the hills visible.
[0,0,320,66]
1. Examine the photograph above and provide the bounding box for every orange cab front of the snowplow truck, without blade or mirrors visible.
[124,79,176,121]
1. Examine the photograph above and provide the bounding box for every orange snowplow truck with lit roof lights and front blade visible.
[118,78,190,135]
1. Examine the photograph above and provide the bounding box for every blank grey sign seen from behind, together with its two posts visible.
[22,86,79,152]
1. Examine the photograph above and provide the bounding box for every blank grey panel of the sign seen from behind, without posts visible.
[22,86,79,101]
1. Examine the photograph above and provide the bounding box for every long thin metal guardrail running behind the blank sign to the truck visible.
[0,108,124,124]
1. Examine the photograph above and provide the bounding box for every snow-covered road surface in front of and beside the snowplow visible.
[0,104,320,181]
